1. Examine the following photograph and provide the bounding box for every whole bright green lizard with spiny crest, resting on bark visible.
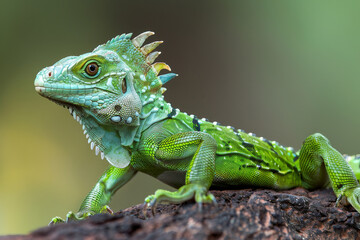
[34,32,360,223]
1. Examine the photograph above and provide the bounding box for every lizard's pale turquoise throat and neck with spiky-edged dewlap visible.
[69,95,172,168]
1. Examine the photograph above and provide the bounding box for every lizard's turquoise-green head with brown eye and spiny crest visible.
[34,32,176,165]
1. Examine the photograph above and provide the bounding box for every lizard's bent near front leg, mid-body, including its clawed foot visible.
[145,132,217,214]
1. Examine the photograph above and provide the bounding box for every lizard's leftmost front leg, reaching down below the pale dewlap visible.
[50,165,136,224]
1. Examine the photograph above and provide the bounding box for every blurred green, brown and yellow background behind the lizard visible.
[0,0,360,234]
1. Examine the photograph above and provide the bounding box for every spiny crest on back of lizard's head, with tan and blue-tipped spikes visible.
[94,31,177,98]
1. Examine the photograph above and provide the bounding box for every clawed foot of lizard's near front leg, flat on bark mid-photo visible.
[143,183,217,217]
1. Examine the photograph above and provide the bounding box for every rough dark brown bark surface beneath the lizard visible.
[1,188,360,240]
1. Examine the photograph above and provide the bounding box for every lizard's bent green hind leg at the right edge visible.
[299,133,360,212]
